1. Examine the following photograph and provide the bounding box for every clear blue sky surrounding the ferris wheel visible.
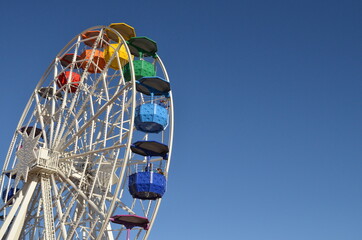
[0,0,362,240]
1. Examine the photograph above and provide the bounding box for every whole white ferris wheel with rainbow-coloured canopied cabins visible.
[0,23,173,240]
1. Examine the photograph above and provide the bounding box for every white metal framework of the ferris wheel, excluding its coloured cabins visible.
[0,23,173,240]
